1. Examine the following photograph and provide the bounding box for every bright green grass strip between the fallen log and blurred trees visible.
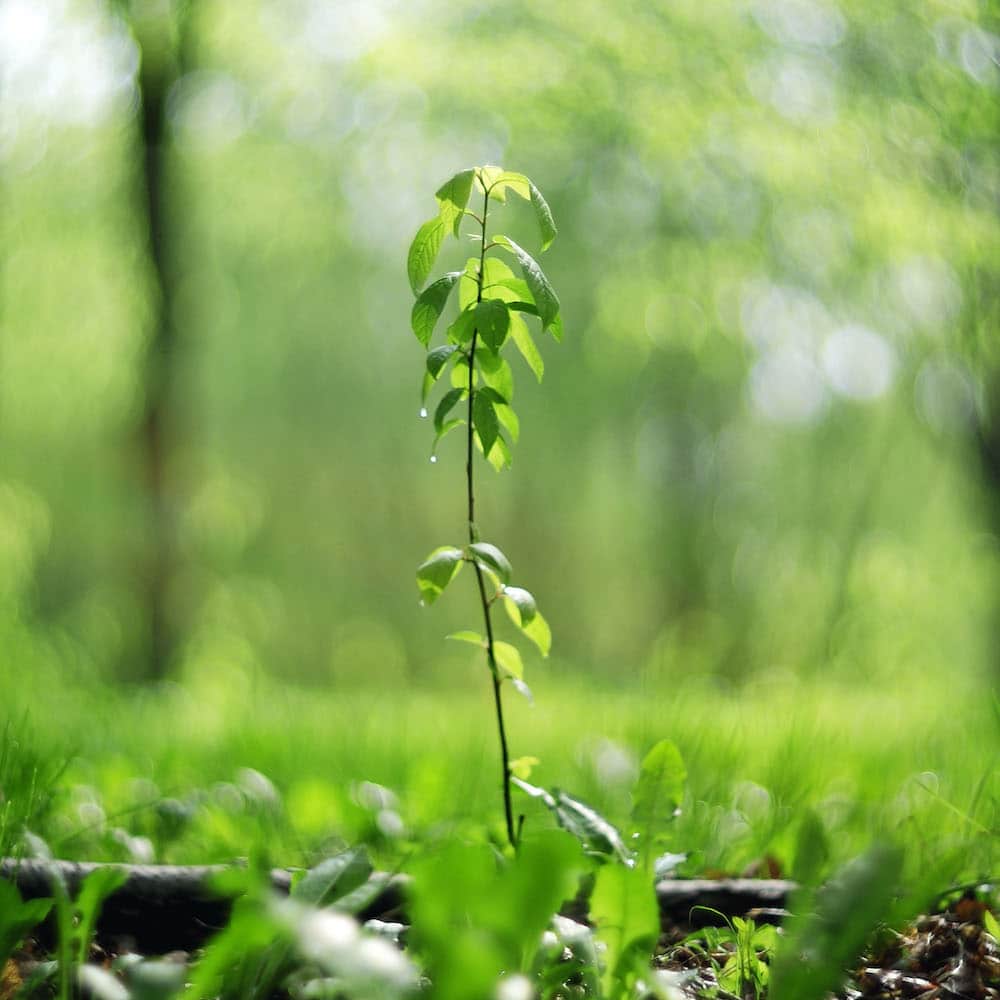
[0,669,1000,888]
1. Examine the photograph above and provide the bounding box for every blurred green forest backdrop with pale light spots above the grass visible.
[0,0,1000,685]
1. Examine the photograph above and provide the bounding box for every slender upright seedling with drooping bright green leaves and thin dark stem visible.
[407,167,562,848]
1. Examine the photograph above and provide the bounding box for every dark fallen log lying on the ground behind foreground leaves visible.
[0,858,796,954]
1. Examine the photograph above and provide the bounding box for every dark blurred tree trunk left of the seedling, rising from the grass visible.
[129,0,190,680]
